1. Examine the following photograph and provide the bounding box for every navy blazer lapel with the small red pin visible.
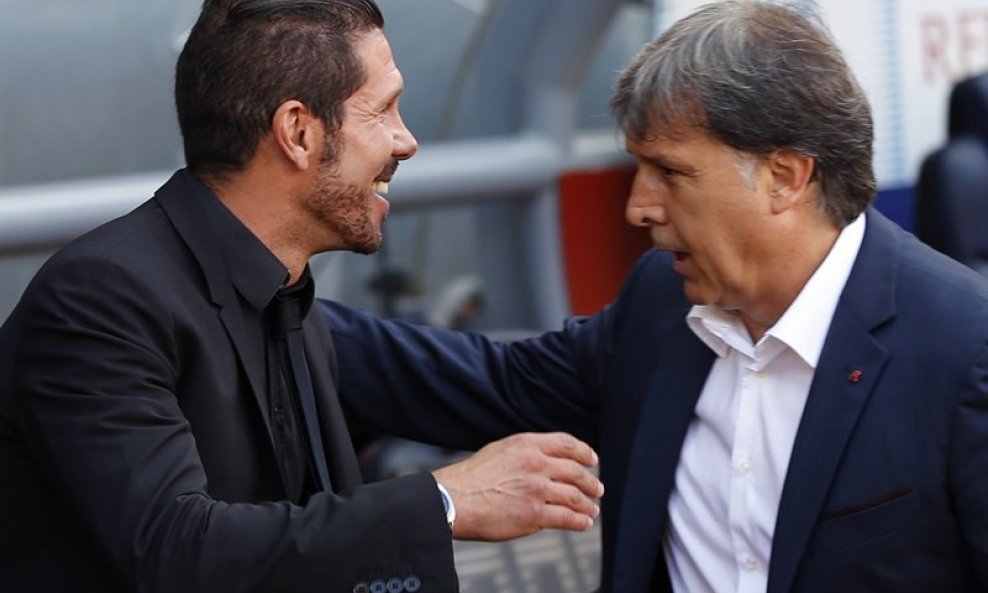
[768,209,898,593]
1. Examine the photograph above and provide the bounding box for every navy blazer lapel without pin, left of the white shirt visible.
[612,322,714,591]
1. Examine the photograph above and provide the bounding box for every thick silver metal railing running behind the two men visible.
[0,132,625,255]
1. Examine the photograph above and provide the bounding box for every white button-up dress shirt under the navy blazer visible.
[664,215,865,593]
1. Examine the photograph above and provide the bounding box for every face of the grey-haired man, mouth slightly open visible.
[626,123,771,310]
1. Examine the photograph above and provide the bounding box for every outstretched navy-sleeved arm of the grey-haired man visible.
[320,301,613,449]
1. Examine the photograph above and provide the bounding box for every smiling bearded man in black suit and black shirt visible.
[0,0,602,593]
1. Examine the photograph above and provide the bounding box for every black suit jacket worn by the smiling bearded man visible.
[0,171,456,593]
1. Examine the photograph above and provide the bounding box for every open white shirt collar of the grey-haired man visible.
[686,214,865,368]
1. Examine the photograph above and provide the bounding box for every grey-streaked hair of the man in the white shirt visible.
[611,0,876,227]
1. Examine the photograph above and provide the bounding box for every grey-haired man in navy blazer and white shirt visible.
[323,0,988,593]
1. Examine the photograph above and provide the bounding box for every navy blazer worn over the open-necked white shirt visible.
[322,209,988,593]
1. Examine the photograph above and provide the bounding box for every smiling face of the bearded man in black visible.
[305,29,417,253]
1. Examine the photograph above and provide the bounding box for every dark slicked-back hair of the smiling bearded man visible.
[175,0,384,178]
